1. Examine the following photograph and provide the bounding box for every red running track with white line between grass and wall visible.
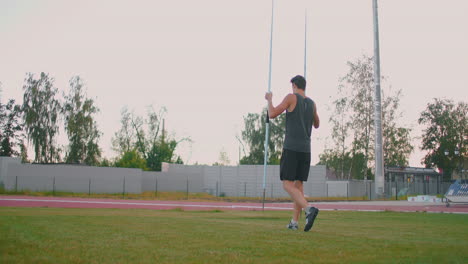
[0,196,468,214]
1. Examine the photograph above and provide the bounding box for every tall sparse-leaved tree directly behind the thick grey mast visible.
[320,55,413,179]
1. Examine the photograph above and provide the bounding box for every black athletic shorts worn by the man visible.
[280,149,310,181]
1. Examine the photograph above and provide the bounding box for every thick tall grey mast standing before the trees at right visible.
[372,0,385,197]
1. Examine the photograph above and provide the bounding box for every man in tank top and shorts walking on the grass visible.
[265,75,320,231]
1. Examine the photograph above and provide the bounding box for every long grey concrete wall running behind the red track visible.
[0,157,450,199]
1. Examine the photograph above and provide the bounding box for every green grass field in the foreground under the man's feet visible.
[0,207,468,263]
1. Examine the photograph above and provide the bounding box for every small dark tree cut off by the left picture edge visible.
[0,99,24,157]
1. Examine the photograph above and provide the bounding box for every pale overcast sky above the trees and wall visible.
[0,0,468,166]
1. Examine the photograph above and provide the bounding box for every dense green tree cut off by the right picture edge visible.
[418,99,468,179]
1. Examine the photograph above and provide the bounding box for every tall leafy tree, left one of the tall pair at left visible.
[22,72,61,163]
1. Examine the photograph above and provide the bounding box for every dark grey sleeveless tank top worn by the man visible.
[283,93,315,152]
